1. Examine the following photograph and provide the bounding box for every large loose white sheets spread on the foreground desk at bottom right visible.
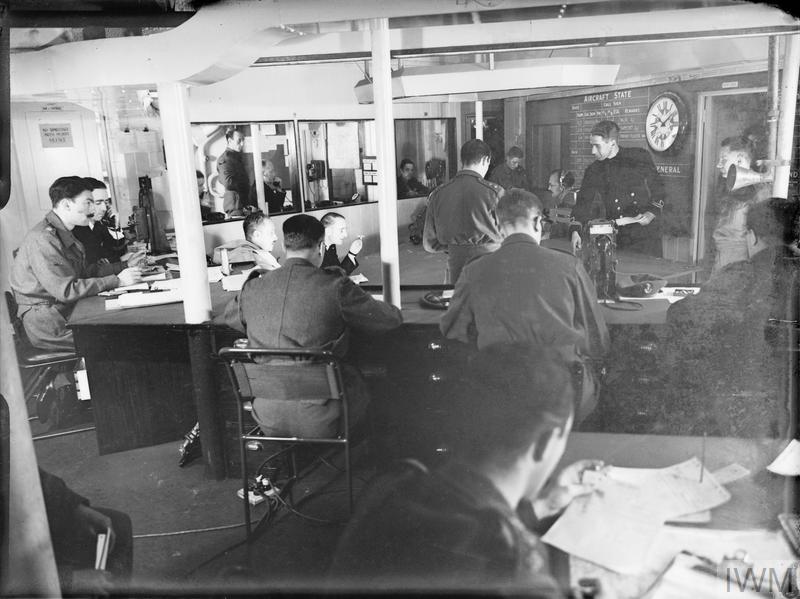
[542,458,730,574]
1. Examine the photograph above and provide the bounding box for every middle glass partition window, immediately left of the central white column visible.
[299,121,376,210]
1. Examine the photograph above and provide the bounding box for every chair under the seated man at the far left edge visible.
[5,291,80,404]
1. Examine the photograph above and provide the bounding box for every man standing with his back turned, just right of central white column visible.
[422,139,503,283]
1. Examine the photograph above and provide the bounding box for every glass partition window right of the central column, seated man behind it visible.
[394,119,457,199]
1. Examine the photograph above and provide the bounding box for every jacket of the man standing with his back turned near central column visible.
[422,169,504,252]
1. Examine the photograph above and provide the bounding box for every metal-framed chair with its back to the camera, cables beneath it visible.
[219,347,353,543]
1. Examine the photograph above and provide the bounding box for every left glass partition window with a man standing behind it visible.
[191,121,300,221]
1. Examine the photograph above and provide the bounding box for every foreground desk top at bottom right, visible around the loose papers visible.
[554,433,792,599]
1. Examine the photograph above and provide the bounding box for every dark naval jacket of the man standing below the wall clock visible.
[571,148,664,229]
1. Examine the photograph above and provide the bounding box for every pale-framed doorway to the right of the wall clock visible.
[692,88,768,269]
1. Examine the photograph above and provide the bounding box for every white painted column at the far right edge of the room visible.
[772,35,800,198]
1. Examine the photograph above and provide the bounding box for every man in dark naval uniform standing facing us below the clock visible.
[570,121,664,257]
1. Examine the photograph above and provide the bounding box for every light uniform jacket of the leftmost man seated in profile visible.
[10,211,126,318]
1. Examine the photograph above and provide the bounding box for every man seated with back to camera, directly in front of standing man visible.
[440,188,610,422]
